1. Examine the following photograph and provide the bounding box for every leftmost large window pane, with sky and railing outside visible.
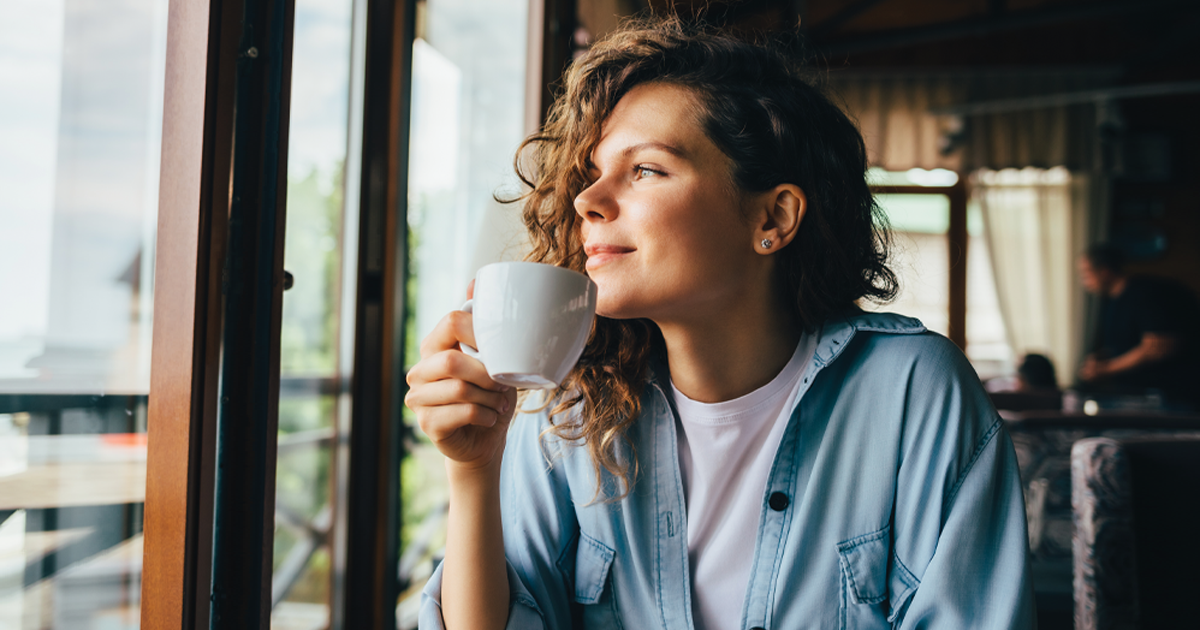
[0,0,167,630]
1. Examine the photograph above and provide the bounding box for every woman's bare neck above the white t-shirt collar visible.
[655,290,800,402]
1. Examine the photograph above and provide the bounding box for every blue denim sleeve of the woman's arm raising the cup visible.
[419,413,578,630]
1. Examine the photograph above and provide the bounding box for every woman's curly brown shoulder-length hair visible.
[516,18,898,494]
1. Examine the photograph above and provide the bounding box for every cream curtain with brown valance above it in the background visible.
[828,73,1116,385]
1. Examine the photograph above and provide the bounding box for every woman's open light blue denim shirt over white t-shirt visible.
[420,313,1034,630]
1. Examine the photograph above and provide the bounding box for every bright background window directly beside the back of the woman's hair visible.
[863,194,950,335]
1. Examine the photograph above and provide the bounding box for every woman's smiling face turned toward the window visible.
[575,84,767,325]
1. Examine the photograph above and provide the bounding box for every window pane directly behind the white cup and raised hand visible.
[397,0,529,628]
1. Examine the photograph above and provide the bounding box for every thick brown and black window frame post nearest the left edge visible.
[140,0,294,629]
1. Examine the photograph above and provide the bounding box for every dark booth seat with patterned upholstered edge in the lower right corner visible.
[1070,436,1200,630]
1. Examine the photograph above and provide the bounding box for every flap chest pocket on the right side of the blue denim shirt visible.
[838,526,920,629]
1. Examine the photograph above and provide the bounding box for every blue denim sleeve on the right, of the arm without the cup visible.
[892,331,1036,630]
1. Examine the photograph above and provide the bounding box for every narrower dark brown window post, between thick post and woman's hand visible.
[345,0,416,630]
